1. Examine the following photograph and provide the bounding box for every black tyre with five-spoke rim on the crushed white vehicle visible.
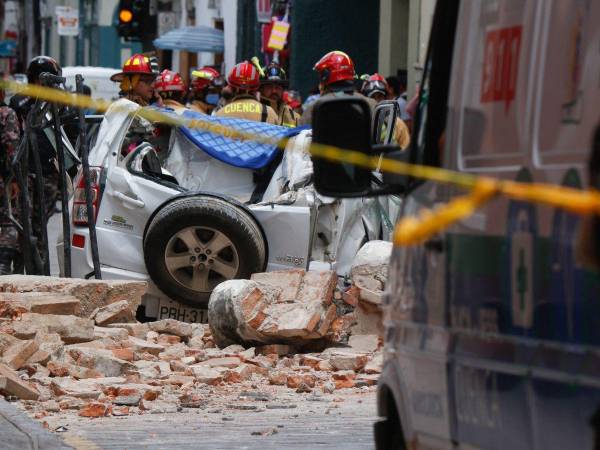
[144,196,267,308]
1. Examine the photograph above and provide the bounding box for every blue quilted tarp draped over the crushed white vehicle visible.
[162,109,307,169]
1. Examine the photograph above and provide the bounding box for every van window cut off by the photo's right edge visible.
[534,0,600,166]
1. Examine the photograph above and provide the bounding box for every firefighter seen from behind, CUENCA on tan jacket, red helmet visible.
[215,61,279,125]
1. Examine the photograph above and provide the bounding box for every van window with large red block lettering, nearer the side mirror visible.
[459,0,540,170]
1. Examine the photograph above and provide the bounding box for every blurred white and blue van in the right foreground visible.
[313,0,600,450]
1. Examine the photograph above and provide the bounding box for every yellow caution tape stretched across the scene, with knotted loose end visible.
[0,81,600,245]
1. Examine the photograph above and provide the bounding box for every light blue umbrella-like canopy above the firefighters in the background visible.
[153,26,225,53]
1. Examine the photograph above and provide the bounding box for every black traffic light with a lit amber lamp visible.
[117,0,156,41]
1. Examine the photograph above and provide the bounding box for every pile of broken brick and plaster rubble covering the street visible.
[0,243,390,419]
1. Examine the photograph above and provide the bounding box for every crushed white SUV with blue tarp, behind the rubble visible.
[57,99,395,322]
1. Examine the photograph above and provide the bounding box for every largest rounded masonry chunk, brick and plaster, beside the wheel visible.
[208,270,337,347]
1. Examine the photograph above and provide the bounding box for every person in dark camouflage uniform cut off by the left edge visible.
[0,84,20,275]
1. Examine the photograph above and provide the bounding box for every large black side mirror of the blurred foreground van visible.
[312,96,372,197]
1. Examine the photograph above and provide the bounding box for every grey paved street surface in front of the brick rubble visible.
[37,388,376,450]
